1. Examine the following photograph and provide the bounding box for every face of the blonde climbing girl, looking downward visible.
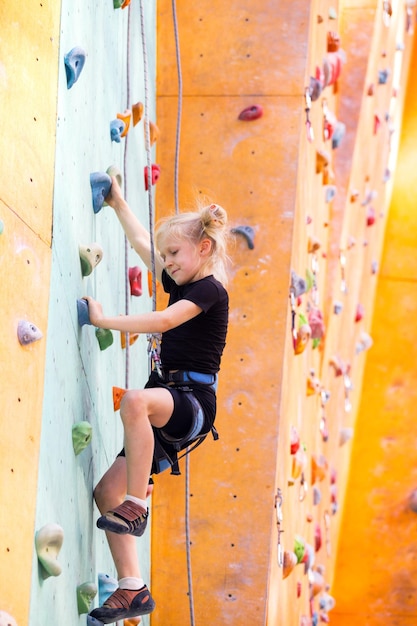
[159,235,210,285]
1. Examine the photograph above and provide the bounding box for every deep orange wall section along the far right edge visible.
[332,22,417,626]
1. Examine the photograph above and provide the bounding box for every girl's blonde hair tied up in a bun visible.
[155,204,228,285]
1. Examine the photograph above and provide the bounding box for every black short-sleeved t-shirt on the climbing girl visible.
[161,270,229,374]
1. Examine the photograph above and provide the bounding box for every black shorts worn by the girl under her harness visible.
[117,372,216,456]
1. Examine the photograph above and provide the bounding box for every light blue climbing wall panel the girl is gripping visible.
[30,0,156,626]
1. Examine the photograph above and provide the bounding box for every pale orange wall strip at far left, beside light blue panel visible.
[0,2,59,624]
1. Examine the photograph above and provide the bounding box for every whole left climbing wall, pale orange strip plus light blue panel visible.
[0,2,156,626]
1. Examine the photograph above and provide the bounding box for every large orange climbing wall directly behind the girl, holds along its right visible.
[151,2,412,626]
